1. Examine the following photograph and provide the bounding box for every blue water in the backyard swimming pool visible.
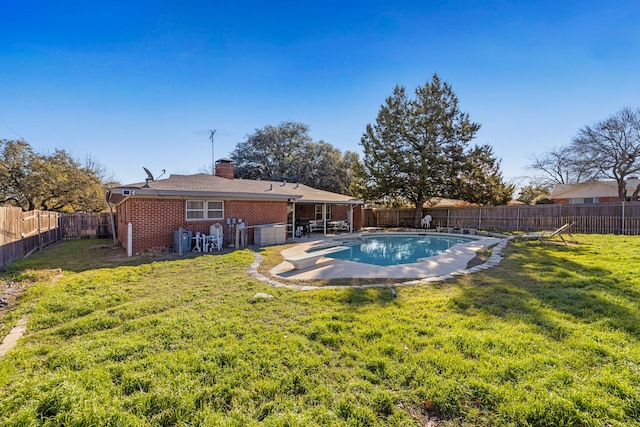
[316,235,473,266]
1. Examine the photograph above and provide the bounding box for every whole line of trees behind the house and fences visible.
[5,74,640,217]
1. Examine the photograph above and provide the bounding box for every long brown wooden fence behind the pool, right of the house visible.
[363,202,640,235]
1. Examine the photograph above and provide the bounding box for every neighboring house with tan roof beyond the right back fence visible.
[550,177,640,205]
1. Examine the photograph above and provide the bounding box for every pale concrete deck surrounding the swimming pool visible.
[269,231,507,287]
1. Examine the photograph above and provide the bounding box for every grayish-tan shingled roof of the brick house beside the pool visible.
[106,173,363,205]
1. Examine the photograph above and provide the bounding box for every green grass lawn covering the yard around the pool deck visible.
[0,235,640,426]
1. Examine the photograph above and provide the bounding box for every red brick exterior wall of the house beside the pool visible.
[117,197,287,254]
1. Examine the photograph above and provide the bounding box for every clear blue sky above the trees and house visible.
[0,0,640,187]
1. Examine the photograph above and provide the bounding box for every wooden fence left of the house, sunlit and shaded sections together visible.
[0,206,112,268]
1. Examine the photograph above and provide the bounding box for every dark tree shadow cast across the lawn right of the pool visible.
[451,244,640,339]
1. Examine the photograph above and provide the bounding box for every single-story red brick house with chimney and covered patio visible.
[106,159,363,253]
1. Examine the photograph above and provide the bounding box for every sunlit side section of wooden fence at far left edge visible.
[0,207,61,268]
